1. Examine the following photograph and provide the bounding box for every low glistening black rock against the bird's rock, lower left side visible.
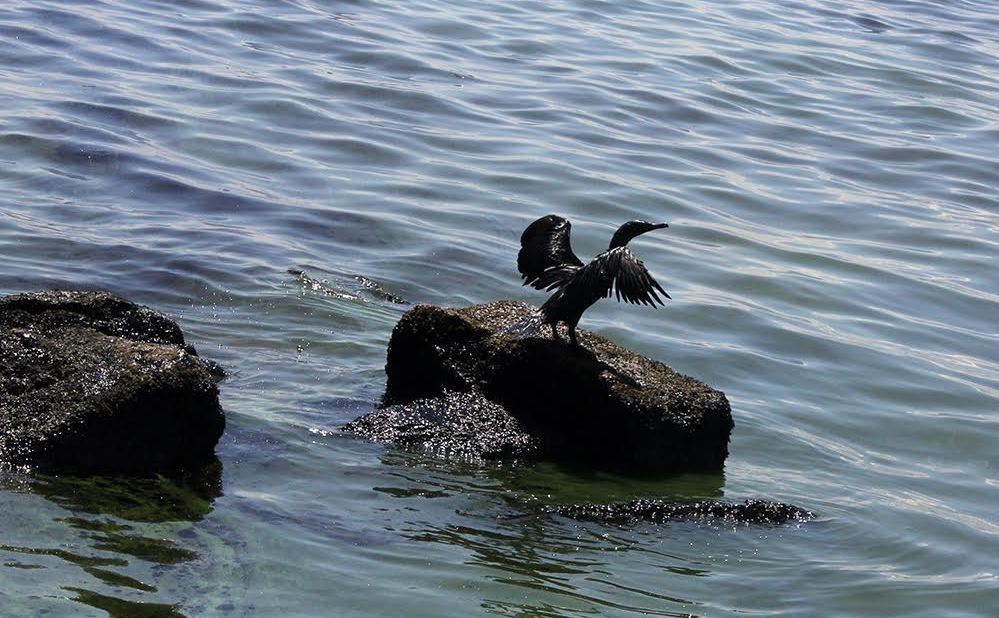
[344,393,538,459]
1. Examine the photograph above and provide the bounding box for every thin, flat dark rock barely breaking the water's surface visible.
[542,500,815,524]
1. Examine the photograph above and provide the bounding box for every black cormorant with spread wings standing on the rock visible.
[517,215,670,345]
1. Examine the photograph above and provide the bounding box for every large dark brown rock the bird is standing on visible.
[375,301,733,472]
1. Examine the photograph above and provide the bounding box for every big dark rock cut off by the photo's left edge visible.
[0,291,225,473]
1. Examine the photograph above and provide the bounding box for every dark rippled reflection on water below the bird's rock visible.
[374,449,740,616]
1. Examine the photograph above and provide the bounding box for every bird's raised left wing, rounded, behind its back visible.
[517,215,583,290]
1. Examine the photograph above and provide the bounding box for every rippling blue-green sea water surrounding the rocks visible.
[0,0,999,617]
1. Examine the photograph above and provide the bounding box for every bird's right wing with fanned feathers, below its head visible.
[571,247,671,306]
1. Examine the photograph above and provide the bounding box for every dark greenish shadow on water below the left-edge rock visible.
[0,459,222,618]
